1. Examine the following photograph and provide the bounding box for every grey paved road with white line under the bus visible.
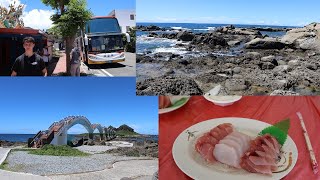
[81,52,136,77]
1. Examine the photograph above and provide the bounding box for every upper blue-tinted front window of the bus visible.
[86,18,121,33]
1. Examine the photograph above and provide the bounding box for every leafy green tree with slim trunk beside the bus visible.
[42,0,92,74]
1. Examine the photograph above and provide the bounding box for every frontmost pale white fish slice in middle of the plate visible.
[213,144,240,168]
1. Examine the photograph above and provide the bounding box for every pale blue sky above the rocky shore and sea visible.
[136,0,320,26]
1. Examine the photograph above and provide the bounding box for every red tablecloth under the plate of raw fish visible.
[159,96,320,180]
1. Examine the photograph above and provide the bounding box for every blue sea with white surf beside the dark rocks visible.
[136,23,294,56]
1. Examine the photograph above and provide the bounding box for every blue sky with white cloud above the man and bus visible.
[0,0,136,29]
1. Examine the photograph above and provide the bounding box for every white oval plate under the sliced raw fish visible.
[172,117,298,180]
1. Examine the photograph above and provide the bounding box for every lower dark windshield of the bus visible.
[88,35,124,53]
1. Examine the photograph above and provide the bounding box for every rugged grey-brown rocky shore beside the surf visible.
[136,23,320,95]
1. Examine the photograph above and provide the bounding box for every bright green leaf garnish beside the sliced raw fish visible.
[259,118,290,145]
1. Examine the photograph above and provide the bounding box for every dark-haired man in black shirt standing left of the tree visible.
[11,37,47,76]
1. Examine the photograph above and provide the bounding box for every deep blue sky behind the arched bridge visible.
[0,77,158,134]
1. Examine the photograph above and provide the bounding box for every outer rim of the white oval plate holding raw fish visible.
[172,117,299,179]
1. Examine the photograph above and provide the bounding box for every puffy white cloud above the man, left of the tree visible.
[22,9,54,30]
